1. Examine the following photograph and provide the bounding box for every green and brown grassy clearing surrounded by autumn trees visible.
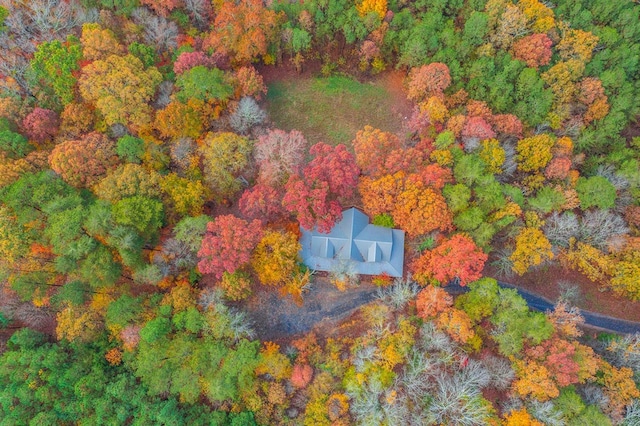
[267,76,401,147]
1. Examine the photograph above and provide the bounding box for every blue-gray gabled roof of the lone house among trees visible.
[300,208,404,277]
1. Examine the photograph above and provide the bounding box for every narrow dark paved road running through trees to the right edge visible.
[445,281,640,334]
